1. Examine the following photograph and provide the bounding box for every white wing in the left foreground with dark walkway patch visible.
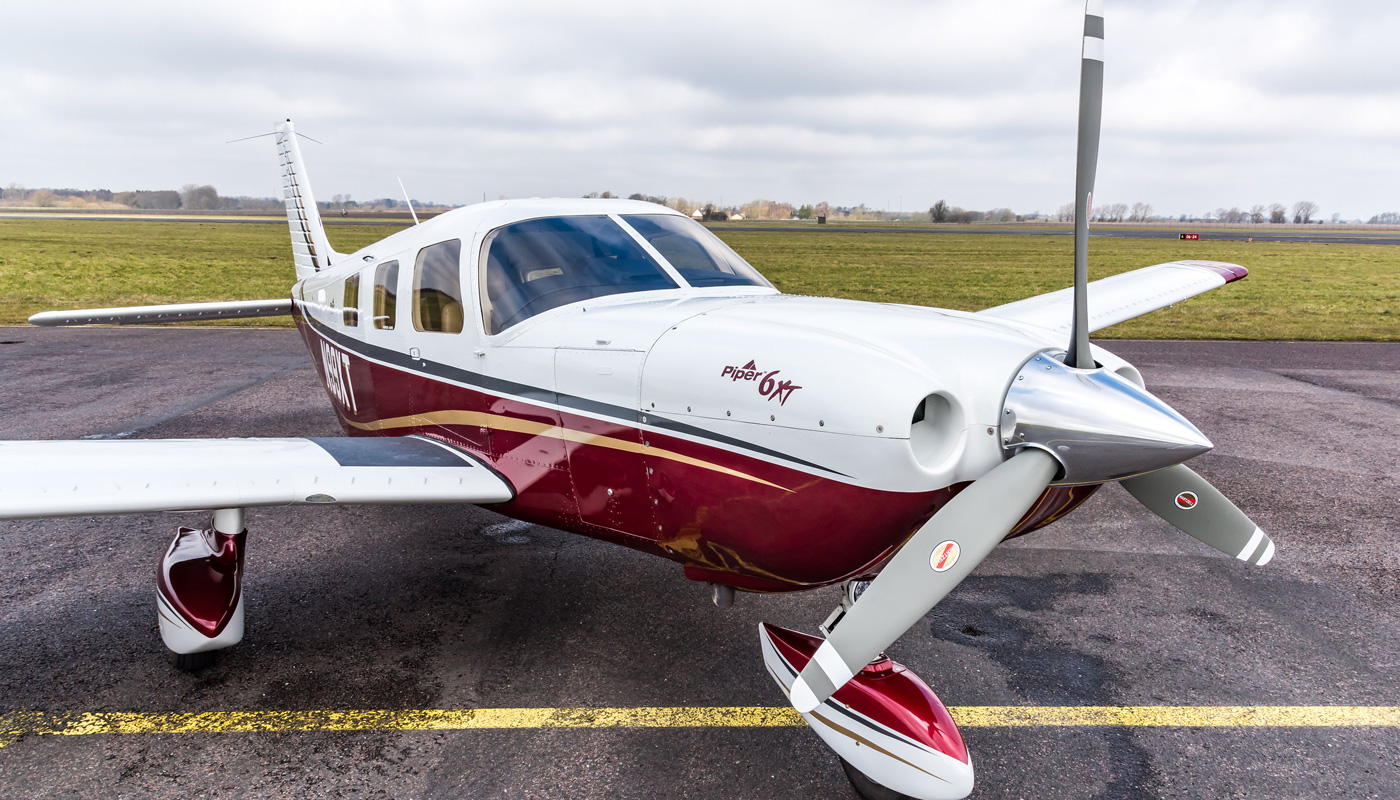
[0,436,515,520]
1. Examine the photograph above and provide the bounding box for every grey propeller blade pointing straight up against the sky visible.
[1065,0,1103,370]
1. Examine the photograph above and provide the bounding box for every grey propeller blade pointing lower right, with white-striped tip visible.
[1119,464,1274,566]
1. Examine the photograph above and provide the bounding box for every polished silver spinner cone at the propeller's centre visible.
[1001,353,1214,486]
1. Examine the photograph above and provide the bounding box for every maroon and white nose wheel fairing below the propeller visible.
[759,622,973,800]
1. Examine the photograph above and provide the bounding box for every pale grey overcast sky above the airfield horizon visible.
[0,0,1400,219]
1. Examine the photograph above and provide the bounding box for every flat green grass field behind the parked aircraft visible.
[0,220,1400,340]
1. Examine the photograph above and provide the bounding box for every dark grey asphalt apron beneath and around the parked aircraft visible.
[0,328,1400,799]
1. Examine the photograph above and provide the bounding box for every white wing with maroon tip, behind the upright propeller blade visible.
[979,261,1249,336]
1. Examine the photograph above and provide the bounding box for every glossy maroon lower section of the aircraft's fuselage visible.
[295,312,1097,591]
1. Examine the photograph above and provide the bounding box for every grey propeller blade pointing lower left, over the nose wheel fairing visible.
[791,447,1060,713]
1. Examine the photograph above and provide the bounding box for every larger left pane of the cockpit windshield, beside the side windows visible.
[479,216,678,333]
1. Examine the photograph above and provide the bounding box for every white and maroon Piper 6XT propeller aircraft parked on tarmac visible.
[0,0,1274,799]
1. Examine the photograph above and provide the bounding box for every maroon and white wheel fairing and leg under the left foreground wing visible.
[155,509,248,671]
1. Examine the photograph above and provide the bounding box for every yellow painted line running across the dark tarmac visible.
[0,706,1400,747]
